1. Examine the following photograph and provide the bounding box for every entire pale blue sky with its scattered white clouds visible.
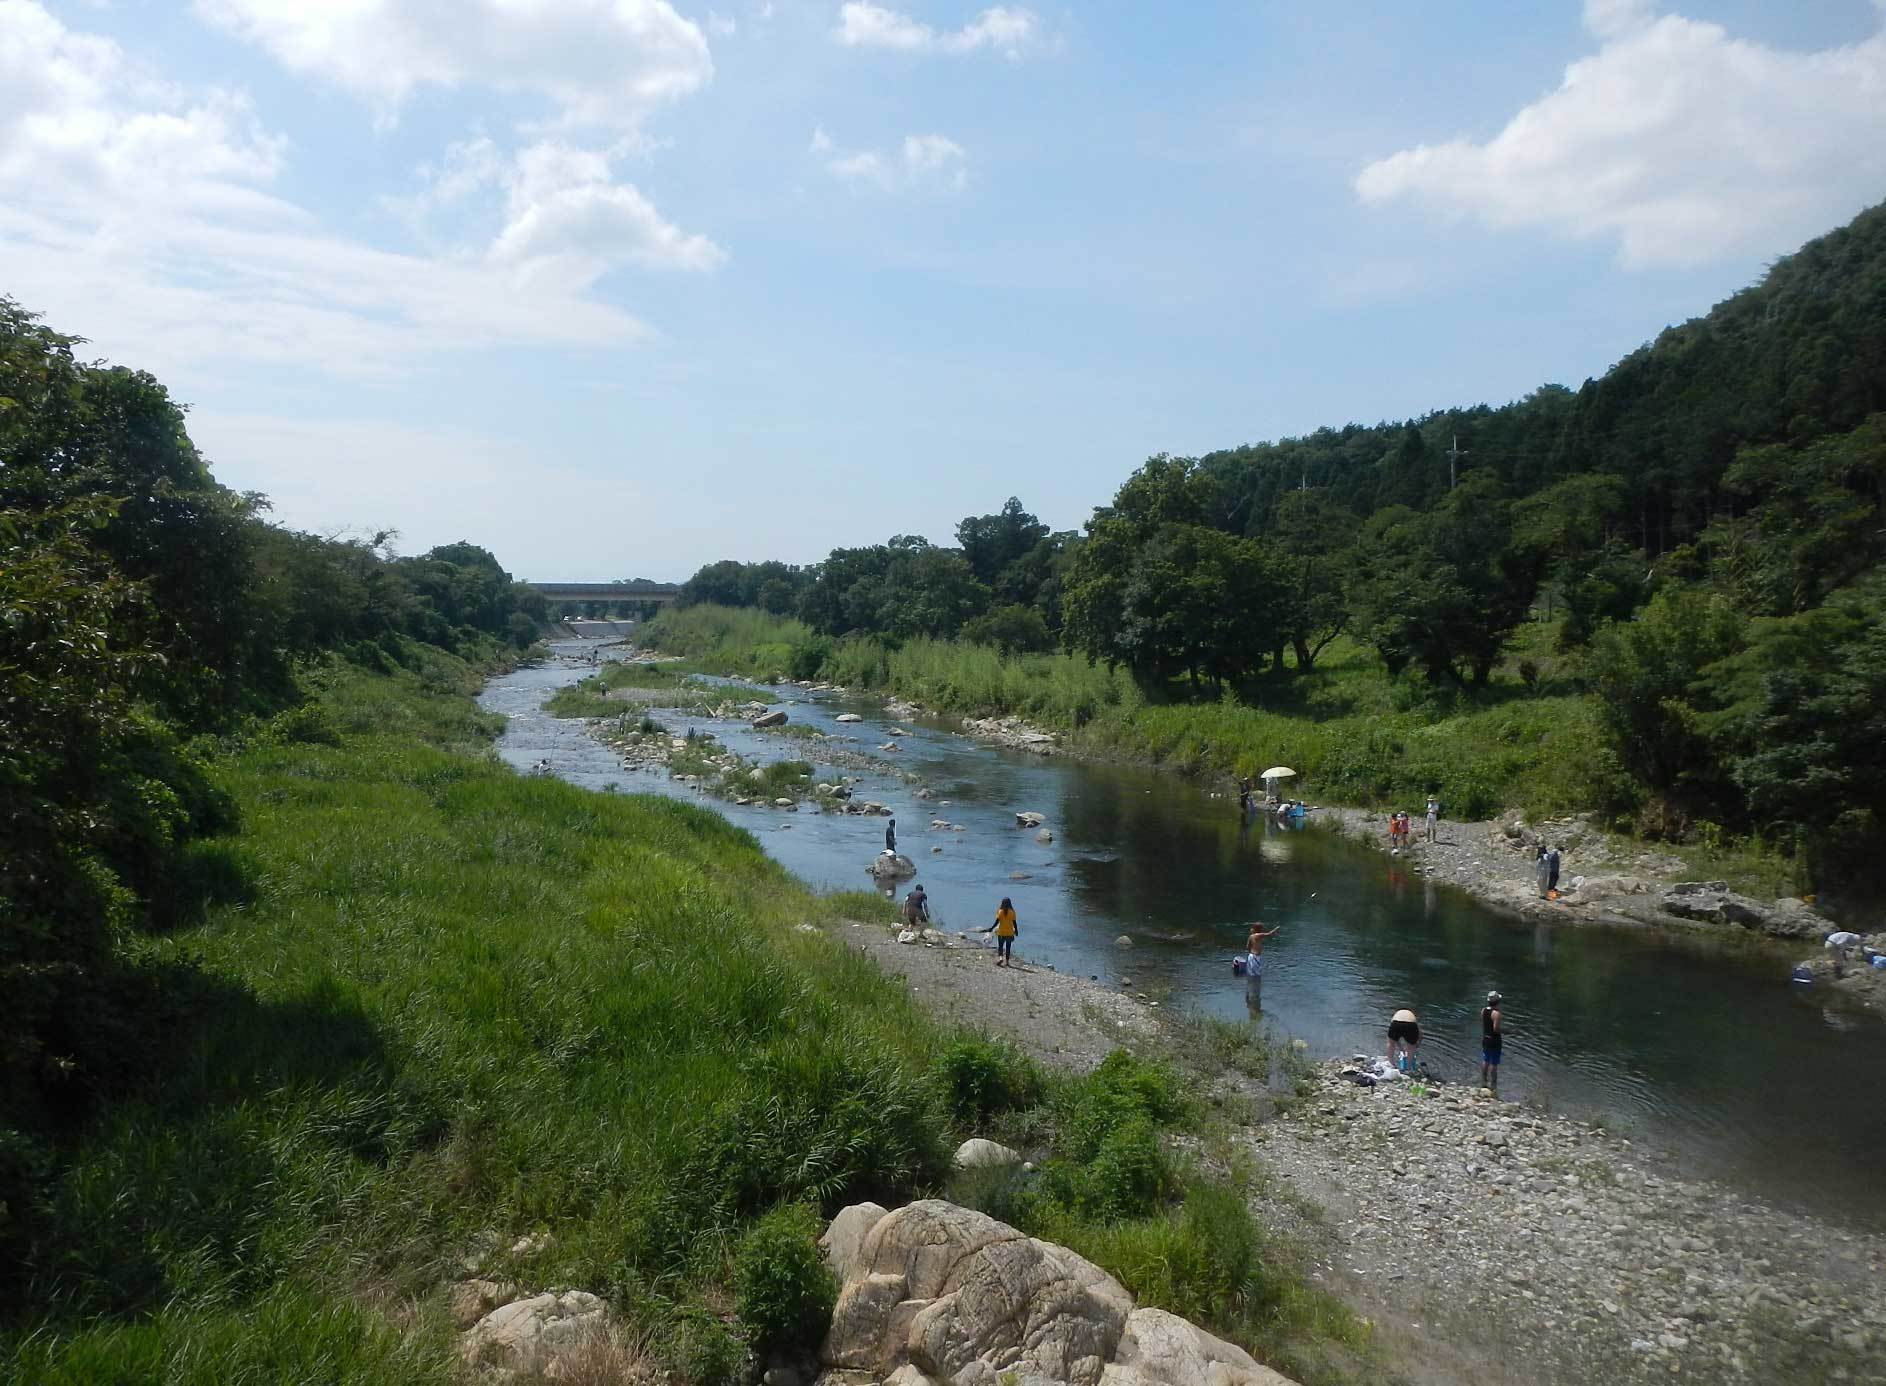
[0,0,1886,579]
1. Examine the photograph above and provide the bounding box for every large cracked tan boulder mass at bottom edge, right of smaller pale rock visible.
[820,1199,1288,1386]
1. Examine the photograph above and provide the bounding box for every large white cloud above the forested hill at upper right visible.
[1356,0,1886,266]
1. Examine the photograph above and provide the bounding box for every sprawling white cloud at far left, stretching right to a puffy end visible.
[0,0,667,377]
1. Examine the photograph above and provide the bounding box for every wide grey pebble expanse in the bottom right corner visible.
[1247,1060,1886,1382]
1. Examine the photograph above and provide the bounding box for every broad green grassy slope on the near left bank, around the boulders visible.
[11,656,1360,1386]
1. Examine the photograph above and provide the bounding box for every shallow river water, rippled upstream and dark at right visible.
[479,643,1886,1224]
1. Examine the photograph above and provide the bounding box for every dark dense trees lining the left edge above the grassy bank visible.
[0,298,541,1280]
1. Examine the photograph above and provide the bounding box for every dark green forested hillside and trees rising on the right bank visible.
[683,207,1886,901]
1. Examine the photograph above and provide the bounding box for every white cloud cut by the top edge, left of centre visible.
[196,0,713,128]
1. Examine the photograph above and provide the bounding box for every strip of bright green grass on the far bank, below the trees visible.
[639,605,1795,898]
